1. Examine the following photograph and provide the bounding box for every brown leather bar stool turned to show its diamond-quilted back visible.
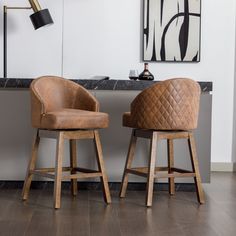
[120,78,204,206]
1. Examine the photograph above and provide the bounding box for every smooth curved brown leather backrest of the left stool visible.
[30,76,99,126]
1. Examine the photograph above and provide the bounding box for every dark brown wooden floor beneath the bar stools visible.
[0,173,236,236]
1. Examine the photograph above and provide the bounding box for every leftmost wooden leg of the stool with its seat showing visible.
[22,130,40,200]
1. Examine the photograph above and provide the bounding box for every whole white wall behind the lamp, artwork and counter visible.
[0,0,235,162]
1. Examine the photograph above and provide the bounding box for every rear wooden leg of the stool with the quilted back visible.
[167,139,175,195]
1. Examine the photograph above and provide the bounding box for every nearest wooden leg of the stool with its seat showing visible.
[54,132,64,209]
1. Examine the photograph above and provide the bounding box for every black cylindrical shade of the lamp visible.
[30,9,53,30]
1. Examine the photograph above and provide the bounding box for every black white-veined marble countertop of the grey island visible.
[0,78,212,92]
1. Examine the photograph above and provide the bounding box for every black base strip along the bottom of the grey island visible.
[0,181,195,192]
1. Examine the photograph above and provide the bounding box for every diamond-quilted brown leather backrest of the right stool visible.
[131,78,201,130]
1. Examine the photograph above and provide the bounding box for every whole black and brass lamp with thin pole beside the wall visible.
[3,0,53,78]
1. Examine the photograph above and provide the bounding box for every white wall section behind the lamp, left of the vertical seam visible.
[0,0,63,78]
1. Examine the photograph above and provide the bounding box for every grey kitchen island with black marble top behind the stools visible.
[0,79,212,183]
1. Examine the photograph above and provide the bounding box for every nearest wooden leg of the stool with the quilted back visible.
[146,132,157,206]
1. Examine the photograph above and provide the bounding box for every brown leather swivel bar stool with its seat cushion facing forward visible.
[22,76,111,208]
